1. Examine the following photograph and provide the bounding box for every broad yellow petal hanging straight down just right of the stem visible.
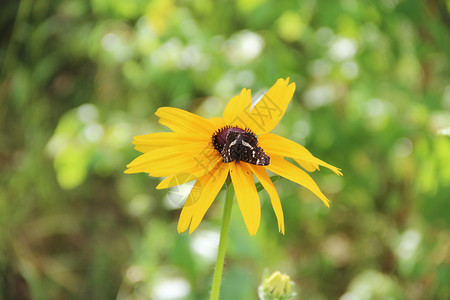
[229,162,261,235]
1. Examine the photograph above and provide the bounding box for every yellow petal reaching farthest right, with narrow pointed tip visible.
[258,133,342,175]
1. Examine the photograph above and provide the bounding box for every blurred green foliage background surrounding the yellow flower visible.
[0,0,450,300]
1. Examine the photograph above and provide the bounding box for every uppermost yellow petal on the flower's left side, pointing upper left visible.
[155,107,216,136]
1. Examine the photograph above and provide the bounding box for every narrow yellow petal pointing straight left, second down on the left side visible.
[133,132,209,153]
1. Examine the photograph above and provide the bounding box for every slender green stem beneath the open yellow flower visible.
[209,180,234,300]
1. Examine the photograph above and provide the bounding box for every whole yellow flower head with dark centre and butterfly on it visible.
[125,78,342,235]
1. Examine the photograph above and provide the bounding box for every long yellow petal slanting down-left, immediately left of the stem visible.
[178,164,228,233]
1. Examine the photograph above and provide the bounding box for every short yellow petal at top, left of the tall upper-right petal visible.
[223,89,252,128]
